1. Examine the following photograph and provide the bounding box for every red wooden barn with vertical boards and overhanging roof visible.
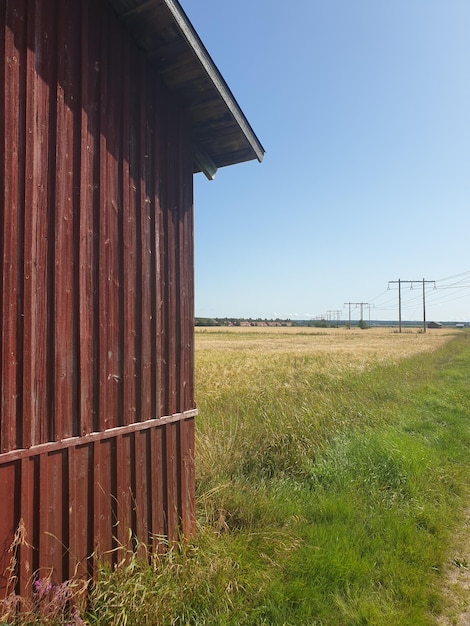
[0,0,263,593]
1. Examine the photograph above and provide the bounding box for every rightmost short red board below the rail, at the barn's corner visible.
[180,418,196,537]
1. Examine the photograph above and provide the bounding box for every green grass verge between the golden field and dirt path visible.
[186,335,470,626]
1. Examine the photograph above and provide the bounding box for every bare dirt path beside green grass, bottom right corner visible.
[437,506,470,626]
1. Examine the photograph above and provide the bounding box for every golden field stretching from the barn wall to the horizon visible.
[195,327,458,486]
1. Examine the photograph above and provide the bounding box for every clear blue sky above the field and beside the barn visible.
[180,0,470,321]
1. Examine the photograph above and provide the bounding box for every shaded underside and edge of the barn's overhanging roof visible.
[109,0,264,178]
